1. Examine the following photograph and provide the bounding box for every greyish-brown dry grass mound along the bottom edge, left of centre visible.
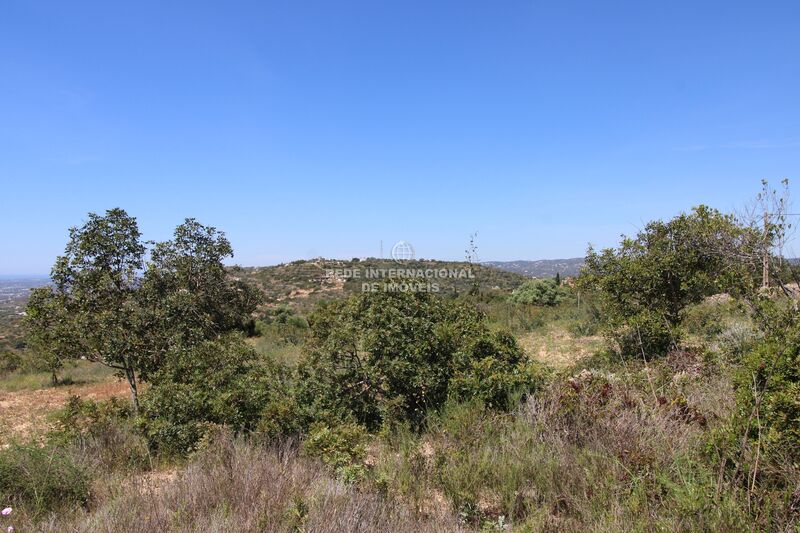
[31,438,459,533]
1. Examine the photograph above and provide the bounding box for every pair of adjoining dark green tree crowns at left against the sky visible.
[26,209,260,406]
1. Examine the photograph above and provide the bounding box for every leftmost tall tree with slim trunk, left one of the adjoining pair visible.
[27,209,145,406]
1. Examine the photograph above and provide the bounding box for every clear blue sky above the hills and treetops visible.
[0,0,800,274]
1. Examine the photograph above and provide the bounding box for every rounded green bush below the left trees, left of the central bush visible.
[141,333,294,455]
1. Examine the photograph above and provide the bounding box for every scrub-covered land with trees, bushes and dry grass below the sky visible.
[0,182,800,532]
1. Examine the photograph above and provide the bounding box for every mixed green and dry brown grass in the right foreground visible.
[377,354,745,531]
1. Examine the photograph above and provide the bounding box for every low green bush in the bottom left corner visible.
[0,444,90,515]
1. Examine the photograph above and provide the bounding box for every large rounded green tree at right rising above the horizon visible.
[579,206,757,357]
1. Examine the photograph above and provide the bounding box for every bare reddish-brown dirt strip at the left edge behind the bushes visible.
[0,380,128,445]
